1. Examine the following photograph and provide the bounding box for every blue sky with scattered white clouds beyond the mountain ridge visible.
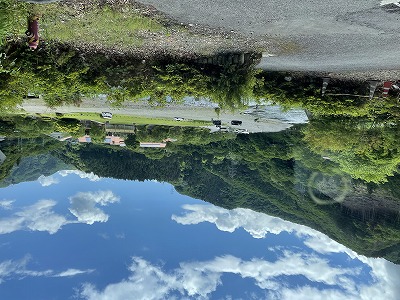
[0,171,400,300]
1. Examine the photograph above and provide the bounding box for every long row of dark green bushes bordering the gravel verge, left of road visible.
[0,44,260,109]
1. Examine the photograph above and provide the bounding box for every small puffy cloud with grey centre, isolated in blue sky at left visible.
[69,191,119,224]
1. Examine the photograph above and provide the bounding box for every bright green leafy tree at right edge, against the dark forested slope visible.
[303,117,400,183]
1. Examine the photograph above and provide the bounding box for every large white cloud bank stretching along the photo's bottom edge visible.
[80,251,399,300]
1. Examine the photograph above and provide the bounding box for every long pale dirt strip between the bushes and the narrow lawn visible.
[21,99,291,132]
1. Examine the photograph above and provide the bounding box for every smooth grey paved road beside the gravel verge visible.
[139,0,400,72]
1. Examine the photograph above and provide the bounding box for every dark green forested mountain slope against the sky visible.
[1,118,400,263]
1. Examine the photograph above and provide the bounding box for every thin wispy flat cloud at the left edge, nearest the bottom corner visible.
[0,255,94,284]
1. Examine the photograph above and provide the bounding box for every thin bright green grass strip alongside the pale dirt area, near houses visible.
[41,112,212,127]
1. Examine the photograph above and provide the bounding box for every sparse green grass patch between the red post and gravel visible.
[41,3,164,49]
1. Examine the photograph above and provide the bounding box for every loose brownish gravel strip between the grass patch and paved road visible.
[48,0,279,59]
